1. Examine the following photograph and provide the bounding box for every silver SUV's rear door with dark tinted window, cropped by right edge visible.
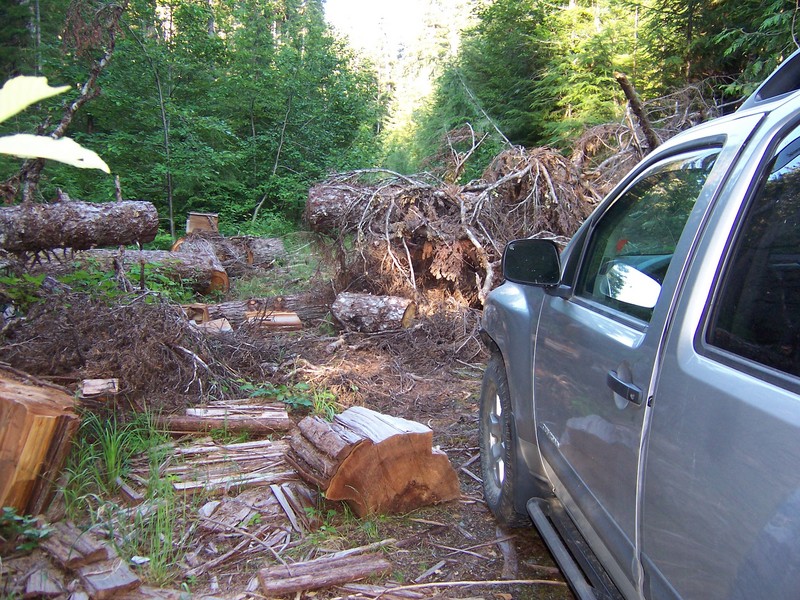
[642,115,800,600]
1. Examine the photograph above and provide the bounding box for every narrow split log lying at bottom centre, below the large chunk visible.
[258,554,392,598]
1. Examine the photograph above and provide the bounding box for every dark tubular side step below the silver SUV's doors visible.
[527,498,622,600]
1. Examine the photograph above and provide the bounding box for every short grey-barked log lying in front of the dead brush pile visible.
[331,292,417,333]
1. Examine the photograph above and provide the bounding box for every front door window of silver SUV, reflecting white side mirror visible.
[577,148,719,321]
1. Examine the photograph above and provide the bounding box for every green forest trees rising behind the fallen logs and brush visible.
[0,0,797,233]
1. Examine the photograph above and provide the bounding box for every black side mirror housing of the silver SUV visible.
[503,239,561,287]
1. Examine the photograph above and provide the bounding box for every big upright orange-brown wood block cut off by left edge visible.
[0,374,79,514]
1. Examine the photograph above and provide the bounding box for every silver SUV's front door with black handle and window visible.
[534,119,757,597]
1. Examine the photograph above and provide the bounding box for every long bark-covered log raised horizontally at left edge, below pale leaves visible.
[0,200,158,252]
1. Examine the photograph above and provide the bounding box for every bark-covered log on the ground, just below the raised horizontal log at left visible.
[65,249,230,294]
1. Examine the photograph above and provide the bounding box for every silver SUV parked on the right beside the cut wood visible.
[480,54,800,600]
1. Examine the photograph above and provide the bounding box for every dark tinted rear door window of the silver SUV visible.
[707,129,800,375]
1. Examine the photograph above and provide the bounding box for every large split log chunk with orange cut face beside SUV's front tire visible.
[286,407,461,517]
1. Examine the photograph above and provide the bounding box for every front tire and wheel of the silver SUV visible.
[478,353,531,527]
